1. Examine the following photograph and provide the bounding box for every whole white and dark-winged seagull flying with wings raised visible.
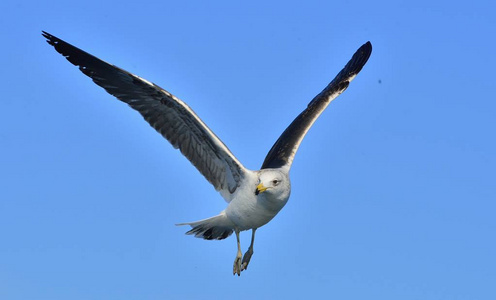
[42,31,372,276]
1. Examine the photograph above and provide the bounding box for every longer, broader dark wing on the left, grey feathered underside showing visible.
[43,32,246,201]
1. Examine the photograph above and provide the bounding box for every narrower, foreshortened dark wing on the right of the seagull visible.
[262,42,372,169]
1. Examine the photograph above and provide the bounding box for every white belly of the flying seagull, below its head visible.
[226,199,286,230]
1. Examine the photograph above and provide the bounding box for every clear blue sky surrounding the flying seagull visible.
[0,0,496,300]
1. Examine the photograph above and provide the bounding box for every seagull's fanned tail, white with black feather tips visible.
[176,212,234,240]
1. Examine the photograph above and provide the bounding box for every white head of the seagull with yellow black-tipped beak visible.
[255,169,291,201]
